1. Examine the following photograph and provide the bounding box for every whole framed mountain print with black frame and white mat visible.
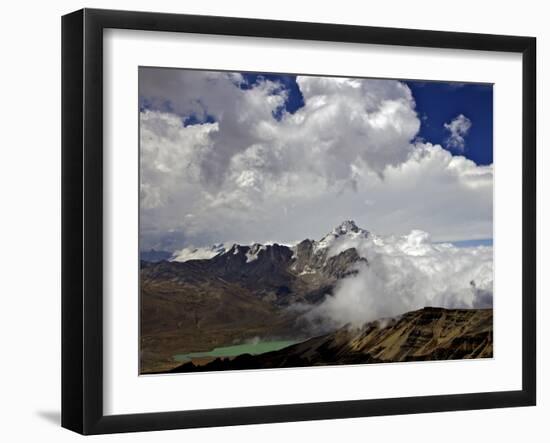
[62,9,536,434]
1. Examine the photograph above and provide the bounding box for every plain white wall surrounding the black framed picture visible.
[0,0,550,443]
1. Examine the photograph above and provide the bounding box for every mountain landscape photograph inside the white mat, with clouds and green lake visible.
[138,66,496,375]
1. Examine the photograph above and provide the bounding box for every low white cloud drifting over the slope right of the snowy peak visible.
[306,230,493,329]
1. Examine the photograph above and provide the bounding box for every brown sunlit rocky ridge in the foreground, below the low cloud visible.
[170,307,493,372]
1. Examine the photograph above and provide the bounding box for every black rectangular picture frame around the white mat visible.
[62,9,536,434]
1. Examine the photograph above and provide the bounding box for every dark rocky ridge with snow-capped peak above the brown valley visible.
[141,221,368,305]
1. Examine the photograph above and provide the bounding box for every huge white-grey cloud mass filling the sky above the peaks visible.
[140,68,493,250]
